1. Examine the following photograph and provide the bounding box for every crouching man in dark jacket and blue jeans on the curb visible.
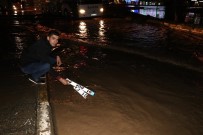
[21,30,68,85]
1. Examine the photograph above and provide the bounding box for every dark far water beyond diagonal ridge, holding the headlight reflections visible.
[41,18,203,70]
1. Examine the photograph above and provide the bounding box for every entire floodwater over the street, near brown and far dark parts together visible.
[0,18,203,135]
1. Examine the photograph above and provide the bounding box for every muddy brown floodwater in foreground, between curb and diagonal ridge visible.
[46,46,203,135]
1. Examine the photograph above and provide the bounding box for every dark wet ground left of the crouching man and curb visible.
[0,18,37,135]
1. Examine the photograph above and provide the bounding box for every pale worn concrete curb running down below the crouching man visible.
[36,81,54,135]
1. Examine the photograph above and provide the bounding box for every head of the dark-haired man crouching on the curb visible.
[47,30,60,47]
